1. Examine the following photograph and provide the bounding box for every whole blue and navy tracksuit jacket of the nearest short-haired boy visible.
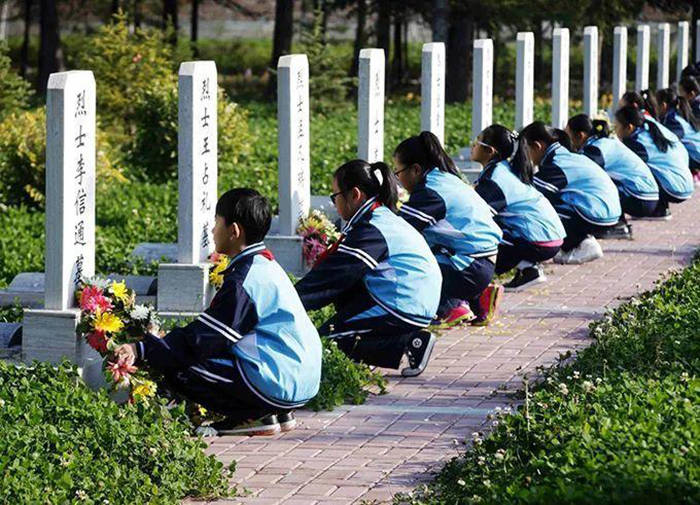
[137,242,321,409]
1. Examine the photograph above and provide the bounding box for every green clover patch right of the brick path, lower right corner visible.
[395,259,700,505]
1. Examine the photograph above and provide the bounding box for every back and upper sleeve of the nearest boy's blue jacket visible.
[213,243,321,408]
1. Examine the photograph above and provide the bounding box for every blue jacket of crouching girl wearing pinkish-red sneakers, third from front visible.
[400,168,502,270]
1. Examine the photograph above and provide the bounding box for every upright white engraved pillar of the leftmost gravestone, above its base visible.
[45,71,95,310]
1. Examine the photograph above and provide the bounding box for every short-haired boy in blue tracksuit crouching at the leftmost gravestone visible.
[117,188,321,435]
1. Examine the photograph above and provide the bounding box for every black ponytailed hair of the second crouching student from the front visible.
[333,160,399,211]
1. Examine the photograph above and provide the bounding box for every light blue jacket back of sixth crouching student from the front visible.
[581,136,659,200]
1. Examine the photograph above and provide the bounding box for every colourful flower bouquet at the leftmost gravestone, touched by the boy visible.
[75,279,159,401]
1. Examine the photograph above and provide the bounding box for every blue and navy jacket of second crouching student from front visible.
[296,198,442,329]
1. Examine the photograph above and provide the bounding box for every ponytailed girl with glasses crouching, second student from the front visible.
[296,160,442,377]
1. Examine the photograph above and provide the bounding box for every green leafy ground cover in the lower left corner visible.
[0,361,235,504]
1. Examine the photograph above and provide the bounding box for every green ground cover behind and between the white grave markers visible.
[0,97,549,288]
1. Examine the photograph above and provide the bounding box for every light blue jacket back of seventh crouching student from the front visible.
[624,124,694,199]
